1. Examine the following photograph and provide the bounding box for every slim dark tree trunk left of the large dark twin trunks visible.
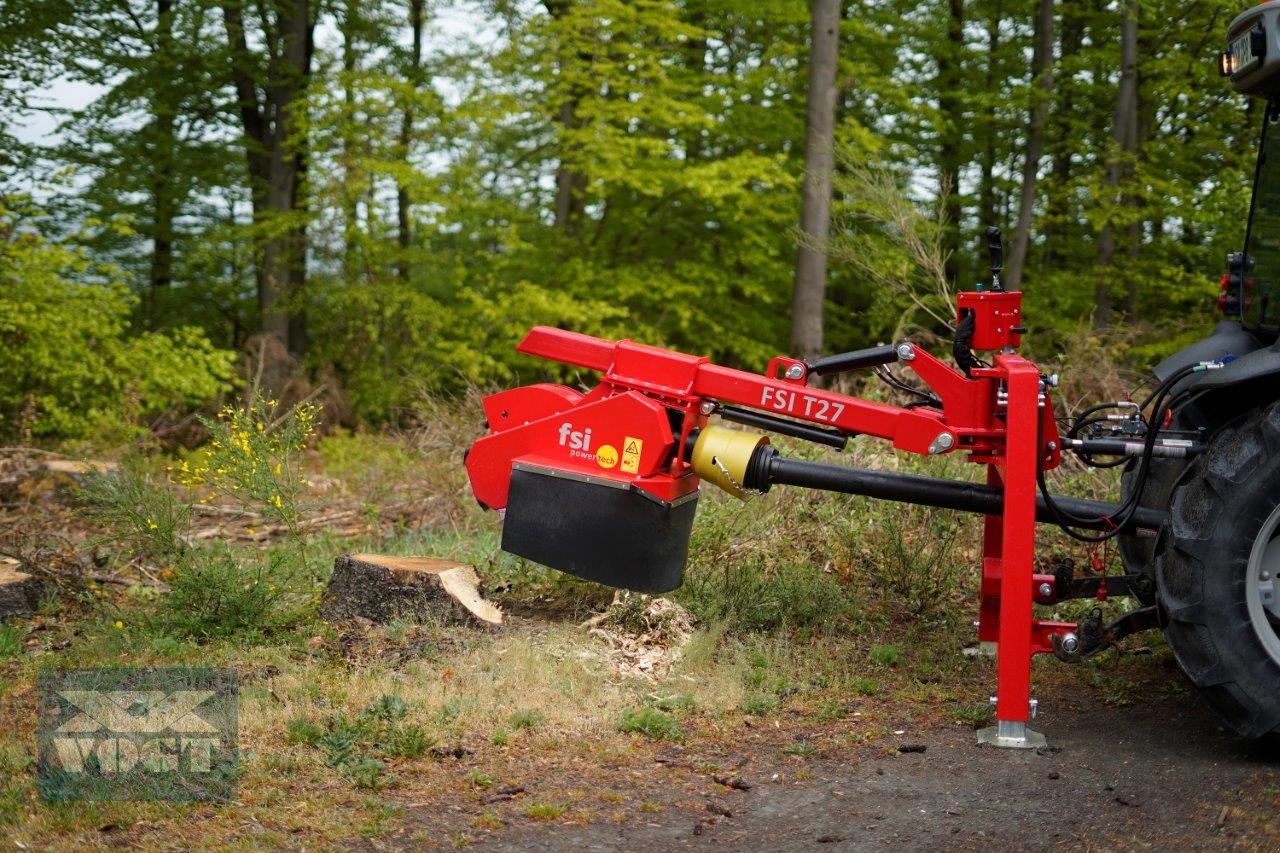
[146,0,178,329]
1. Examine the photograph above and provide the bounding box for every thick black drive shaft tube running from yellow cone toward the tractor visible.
[746,447,1166,533]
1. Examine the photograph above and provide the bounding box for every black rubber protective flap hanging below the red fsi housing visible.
[502,467,698,593]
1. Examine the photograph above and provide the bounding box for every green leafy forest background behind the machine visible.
[0,0,1260,443]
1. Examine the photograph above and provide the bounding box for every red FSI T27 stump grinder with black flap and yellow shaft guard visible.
[466,281,1075,747]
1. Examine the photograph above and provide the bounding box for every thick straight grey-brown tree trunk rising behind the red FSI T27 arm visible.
[791,0,840,360]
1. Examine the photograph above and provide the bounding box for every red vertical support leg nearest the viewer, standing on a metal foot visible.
[983,355,1044,748]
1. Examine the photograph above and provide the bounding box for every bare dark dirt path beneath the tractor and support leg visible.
[383,690,1280,850]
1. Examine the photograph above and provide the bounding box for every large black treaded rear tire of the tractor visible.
[1156,403,1280,738]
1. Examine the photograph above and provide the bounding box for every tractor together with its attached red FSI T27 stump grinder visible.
[465,0,1280,748]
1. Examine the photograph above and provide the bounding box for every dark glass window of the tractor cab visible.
[1243,101,1280,328]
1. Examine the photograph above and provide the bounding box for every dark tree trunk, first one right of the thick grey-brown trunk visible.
[937,0,964,284]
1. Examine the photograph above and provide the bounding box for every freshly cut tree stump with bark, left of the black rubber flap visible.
[320,553,502,628]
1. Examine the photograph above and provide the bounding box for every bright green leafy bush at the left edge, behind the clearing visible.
[0,200,232,438]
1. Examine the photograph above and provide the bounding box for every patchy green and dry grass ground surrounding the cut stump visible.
[0,402,1172,848]
